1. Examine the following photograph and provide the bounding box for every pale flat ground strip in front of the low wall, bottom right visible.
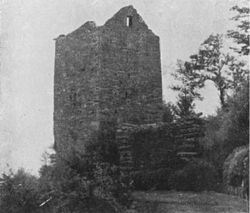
[130,191,248,213]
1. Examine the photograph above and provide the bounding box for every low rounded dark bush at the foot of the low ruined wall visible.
[169,159,217,191]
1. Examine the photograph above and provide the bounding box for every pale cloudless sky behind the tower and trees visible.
[0,0,235,174]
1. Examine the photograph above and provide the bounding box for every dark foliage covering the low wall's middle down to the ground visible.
[130,124,192,190]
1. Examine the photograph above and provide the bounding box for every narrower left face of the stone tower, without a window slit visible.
[54,22,100,153]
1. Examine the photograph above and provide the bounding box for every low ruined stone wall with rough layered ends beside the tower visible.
[116,116,204,173]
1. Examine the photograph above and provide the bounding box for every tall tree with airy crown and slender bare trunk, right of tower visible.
[188,34,234,108]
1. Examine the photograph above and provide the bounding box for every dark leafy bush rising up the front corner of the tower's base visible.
[42,122,129,212]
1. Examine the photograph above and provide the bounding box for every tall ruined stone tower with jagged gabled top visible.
[54,6,162,150]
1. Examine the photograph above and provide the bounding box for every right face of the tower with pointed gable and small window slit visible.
[99,7,162,124]
